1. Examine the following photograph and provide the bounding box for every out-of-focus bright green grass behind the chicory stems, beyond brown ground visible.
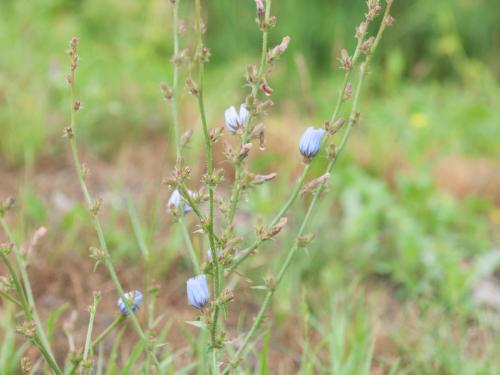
[0,0,500,375]
